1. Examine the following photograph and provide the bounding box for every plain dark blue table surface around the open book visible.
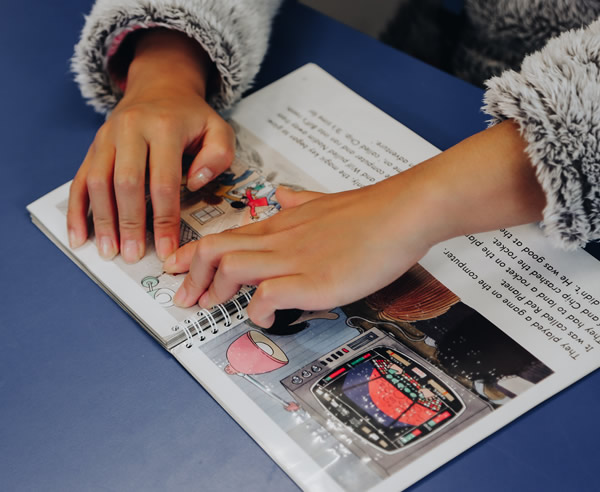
[0,0,600,492]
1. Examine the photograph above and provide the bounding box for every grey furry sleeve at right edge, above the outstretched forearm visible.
[483,20,600,249]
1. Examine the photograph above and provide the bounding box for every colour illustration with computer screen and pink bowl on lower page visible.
[189,265,552,490]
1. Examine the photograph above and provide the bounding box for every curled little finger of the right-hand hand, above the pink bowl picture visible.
[247,274,322,328]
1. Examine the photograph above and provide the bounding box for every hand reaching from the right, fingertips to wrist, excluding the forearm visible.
[164,176,430,327]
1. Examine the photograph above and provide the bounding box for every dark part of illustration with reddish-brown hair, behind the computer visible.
[344,264,552,407]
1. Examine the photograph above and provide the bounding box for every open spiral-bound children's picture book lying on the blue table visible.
[28,65,600,491]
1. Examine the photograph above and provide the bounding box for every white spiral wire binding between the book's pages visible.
[174,286,255,348]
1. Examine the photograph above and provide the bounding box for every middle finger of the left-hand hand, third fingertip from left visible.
[114,137,148,263]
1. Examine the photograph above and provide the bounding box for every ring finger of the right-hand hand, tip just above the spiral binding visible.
[198,251,290,309]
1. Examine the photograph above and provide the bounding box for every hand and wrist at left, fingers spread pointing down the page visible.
[67,30,235,263]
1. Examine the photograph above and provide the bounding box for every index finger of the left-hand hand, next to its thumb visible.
[150,140,183,260]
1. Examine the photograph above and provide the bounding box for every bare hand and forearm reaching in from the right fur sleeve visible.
[164,121,545,327]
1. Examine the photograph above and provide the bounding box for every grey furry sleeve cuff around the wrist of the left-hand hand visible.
[71,0,281,112]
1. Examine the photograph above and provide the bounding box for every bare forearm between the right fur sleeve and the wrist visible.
[400,121,545,245]
